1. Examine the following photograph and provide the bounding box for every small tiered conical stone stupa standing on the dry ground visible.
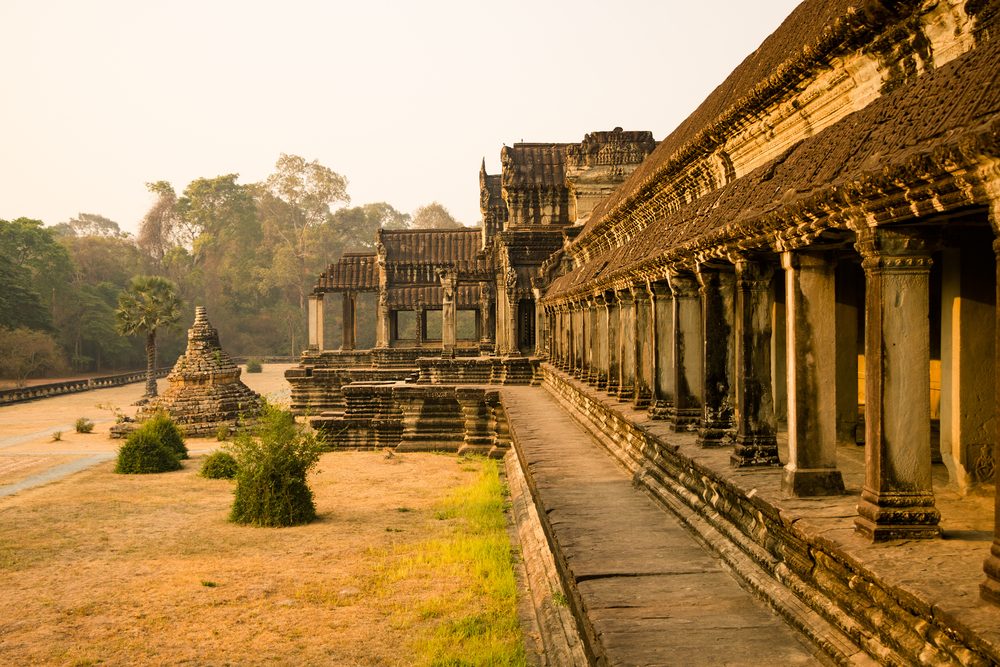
[143,306,261,437]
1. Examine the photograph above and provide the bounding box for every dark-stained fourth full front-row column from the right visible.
[697,267,734,447]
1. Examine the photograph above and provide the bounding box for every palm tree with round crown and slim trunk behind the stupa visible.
[115,276,181,398]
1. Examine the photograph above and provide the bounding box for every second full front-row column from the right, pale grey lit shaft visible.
[781,252,844,496]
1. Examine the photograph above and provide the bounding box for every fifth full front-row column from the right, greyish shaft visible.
[669,273,705,431]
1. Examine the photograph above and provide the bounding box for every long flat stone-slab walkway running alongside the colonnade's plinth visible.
[503,387,819,665]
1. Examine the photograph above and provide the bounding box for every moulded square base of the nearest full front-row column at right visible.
[854,489,941,542]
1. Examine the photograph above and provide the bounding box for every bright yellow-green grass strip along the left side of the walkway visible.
[373,459,525,665]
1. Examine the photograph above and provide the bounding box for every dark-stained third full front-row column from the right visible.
[730,258,781,468]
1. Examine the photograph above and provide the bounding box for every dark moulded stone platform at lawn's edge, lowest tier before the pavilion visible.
[310,382,510,458]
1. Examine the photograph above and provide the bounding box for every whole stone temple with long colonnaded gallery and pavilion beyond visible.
[289,0,1000,664]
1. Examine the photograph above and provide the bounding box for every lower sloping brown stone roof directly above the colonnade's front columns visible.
[548,34,1000,295]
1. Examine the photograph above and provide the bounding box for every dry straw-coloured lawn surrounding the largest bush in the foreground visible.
[0,452,516,665]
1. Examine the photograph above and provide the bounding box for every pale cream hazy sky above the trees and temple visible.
[0,0,798,231]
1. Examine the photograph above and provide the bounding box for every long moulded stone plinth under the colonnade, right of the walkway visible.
[542,364,1000,665]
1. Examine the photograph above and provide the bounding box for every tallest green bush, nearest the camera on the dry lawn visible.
[229,405,320,526]
